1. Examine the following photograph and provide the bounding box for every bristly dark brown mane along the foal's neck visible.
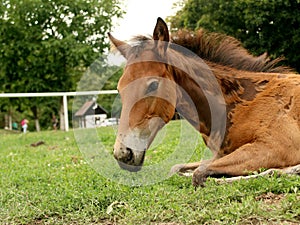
[172,29,293,73]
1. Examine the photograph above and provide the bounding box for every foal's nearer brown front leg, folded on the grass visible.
[193,142,300,186]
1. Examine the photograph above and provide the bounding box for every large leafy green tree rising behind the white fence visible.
[0,0,123,131]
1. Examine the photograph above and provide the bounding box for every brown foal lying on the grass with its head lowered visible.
[109,18,300,186]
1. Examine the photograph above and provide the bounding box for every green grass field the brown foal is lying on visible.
[0,123,300,225]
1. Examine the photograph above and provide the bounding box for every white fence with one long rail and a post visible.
[0,90,118,131]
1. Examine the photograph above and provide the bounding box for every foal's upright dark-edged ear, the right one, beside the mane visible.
[153,17,170,54]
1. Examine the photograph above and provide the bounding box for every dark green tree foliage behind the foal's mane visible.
[169,0,300,72]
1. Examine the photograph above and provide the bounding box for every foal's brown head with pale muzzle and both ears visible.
[109,18,176,171]
